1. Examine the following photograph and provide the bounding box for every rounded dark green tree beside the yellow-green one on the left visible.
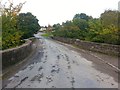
[17,12,40,39]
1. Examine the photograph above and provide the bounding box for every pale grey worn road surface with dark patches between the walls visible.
[3,33,118,88]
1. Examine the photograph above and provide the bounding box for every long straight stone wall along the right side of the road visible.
[53,37,120,56]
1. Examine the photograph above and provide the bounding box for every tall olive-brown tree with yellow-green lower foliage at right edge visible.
[100,10,120,44]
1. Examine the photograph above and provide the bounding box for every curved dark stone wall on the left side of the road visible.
[0,40,32,69]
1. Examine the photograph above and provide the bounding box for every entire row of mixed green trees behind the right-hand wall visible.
[53,10,120,45]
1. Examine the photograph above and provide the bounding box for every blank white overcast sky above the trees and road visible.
[1,0,120,26]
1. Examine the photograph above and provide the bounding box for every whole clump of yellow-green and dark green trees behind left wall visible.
[0,3,40,50]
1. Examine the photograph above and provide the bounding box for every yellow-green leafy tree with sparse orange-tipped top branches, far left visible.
[0,2,24,49]
